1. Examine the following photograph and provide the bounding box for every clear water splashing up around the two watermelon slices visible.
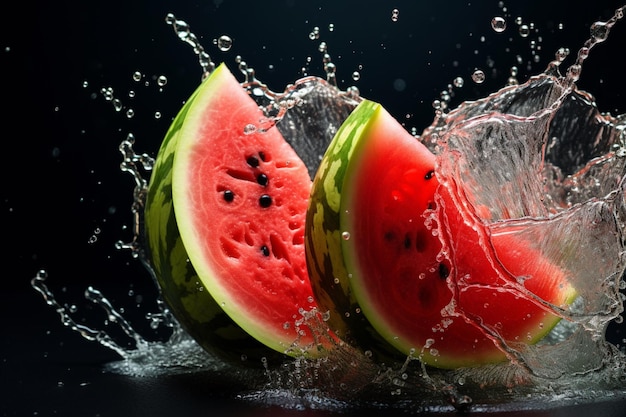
[32,4,626,412]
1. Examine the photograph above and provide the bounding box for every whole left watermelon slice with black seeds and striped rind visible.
[145,64,318,364]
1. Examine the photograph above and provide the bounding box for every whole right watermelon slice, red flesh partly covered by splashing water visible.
[307,101,575,368]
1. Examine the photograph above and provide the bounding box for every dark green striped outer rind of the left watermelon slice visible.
[144,65,282,364]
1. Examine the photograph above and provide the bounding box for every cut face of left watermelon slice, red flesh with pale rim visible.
[172,65,322,353]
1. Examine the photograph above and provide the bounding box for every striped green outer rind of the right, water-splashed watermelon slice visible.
[306,100,402,361]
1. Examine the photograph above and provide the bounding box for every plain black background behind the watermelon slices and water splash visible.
[0,0,626,416]
